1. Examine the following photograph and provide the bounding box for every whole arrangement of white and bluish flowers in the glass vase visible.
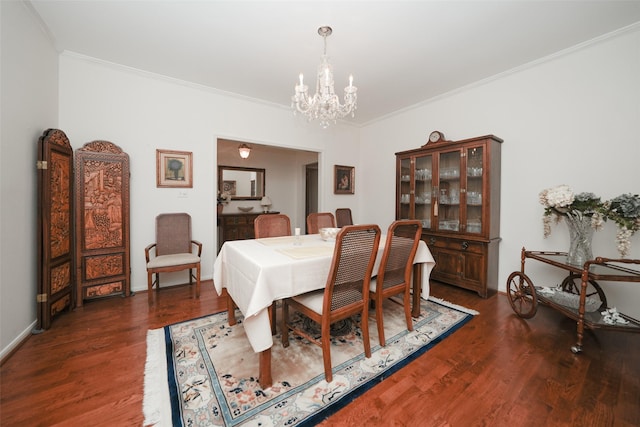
[539,185,640,258]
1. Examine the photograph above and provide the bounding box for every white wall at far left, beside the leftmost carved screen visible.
[0,1,58,356]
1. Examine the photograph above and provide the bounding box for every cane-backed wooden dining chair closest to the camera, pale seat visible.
[282,224,380,382]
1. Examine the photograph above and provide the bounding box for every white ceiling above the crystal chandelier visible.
[29,0,640,124]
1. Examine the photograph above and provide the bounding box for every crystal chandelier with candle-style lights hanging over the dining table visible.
[291,27,358,129]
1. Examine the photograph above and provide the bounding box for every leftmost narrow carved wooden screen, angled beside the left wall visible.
[33,129,74,333]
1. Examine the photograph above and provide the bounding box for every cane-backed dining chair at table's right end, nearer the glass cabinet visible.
[369,220,422,347]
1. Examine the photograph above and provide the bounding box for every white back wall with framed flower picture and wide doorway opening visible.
[59,53,358,300]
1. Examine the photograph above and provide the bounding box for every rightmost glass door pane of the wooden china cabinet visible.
[466,147,486,234]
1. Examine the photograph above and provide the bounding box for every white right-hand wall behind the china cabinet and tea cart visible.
[359,25,640,318]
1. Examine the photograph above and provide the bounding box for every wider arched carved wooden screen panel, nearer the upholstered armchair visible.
[75,141,131,306]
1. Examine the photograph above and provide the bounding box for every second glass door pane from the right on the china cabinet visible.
[437,150,461,231]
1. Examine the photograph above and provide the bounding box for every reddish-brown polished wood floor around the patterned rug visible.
[0,282,640,427]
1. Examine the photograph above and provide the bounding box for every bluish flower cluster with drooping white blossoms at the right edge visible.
[605,193,640,257]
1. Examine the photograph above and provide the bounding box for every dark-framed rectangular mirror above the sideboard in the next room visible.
[218,166,265,200]
